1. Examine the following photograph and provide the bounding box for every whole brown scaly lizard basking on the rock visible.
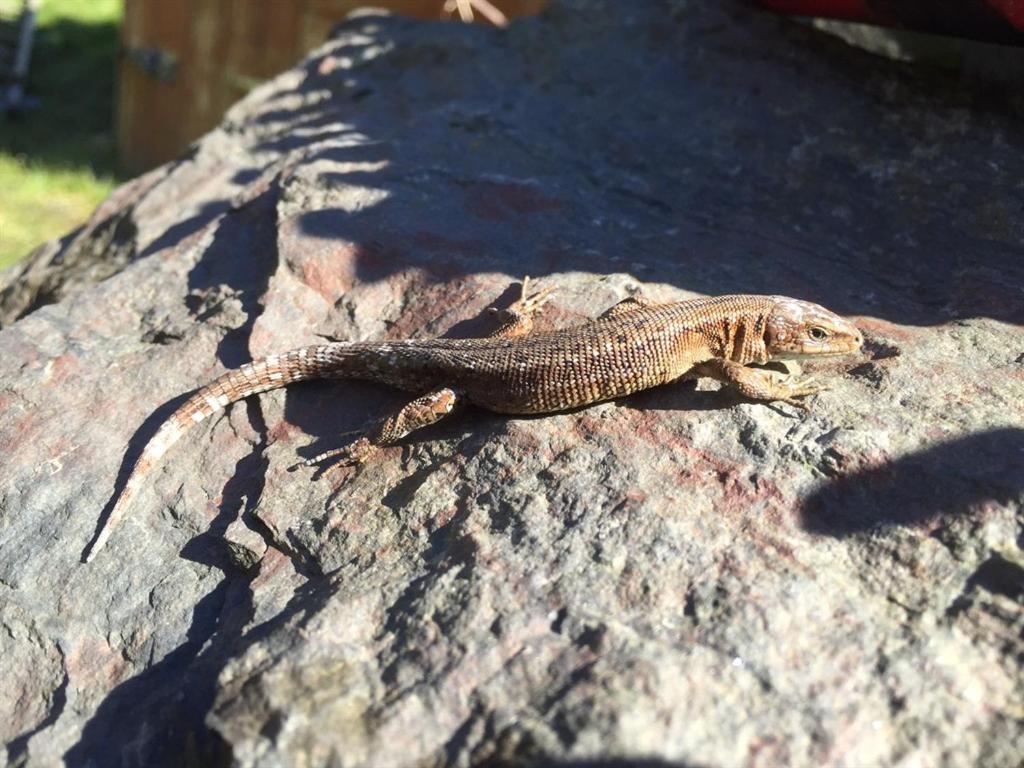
[85,278,863,562]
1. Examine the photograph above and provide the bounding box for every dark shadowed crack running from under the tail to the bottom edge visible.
[65,393,335,766]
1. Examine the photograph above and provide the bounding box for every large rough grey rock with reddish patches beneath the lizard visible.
[0,0,1024,767]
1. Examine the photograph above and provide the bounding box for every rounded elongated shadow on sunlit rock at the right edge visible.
[802,428,1024,537]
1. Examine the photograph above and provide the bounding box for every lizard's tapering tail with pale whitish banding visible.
[85,344,335,562]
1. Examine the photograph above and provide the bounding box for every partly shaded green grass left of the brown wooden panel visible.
[0,0,122,267]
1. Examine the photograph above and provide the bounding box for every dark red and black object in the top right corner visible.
[758,0,1024,45]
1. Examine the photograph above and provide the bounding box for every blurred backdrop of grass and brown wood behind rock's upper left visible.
[0,0,546,268]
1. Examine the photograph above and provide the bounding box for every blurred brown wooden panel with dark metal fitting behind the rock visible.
[117,0,547,171]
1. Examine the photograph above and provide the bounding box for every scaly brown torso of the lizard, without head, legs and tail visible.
[328,296,774,414]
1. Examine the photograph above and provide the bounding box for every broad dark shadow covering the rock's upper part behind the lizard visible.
[267,9,1024,325]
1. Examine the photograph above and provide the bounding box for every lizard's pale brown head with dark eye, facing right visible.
[764,296,864,359]
